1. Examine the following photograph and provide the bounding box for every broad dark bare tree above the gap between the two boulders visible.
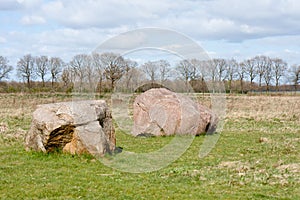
[100,53,125,90]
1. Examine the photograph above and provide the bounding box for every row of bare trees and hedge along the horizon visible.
[0,52,300,93]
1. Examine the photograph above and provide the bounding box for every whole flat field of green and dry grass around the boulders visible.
[0,94,300,199]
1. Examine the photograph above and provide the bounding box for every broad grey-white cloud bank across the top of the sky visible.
[11,0,300,41]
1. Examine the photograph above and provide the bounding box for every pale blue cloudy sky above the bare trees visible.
[0,0,300,72]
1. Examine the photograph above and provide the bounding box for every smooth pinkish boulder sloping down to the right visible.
[132,88,218,136]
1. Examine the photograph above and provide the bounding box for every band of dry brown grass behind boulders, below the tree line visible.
[0,94,300,123]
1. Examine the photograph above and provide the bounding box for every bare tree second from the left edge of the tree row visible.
[17,54,35,88]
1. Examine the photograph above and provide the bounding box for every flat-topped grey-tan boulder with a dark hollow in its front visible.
[25,100,116,157]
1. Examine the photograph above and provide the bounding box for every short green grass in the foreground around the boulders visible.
[0,119,300,199]
